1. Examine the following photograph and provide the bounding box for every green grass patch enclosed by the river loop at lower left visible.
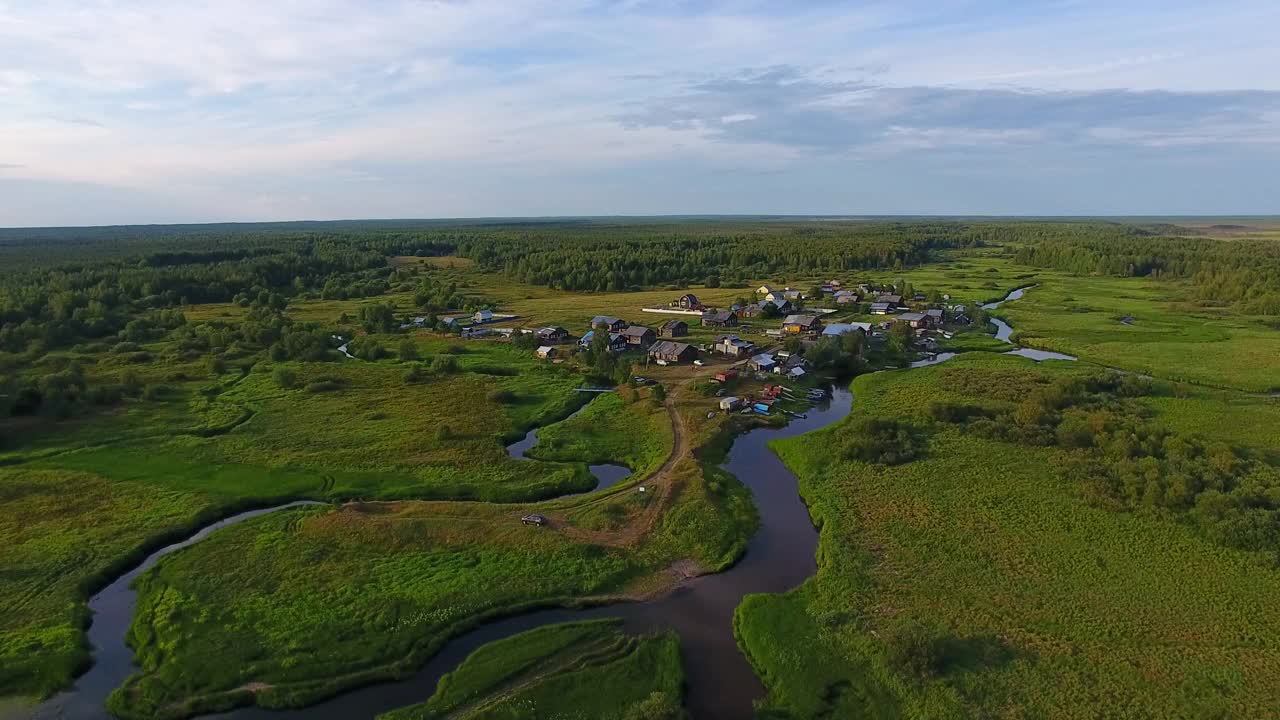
[109,503,643,717]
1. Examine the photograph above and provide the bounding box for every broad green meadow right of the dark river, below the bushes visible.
[737,354,1280,717]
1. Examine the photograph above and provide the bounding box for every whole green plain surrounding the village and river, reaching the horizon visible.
[0,217,1280,720]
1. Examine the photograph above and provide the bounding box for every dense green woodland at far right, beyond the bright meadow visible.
[1015,234,1280,315]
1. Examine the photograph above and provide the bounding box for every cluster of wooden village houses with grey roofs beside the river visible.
[422,279,973,415]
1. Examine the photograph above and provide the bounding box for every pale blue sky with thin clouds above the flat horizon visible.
[0,0,1280,227]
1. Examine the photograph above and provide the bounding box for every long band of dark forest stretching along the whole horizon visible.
[0,219,1280,352]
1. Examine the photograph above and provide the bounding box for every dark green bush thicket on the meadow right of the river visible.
[931,372,1280,551]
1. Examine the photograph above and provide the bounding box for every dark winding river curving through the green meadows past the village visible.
[35,288,1075,720]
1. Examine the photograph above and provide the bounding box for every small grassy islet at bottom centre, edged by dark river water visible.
[381,620,684,720]
